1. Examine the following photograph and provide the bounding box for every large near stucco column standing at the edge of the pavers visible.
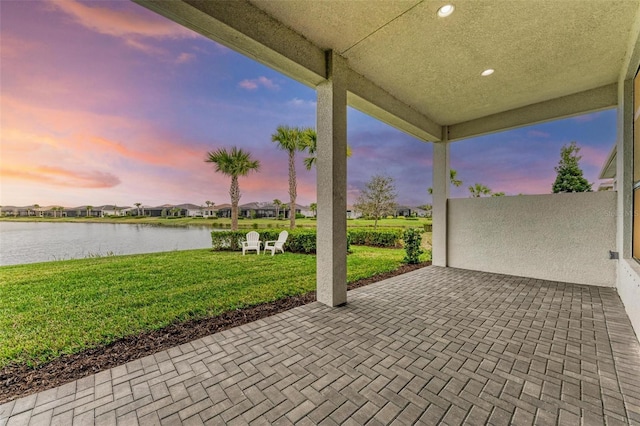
[316,52,347,306]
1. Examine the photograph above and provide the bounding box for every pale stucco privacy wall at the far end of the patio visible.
[447,191,617,287]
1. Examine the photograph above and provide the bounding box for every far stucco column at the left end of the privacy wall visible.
[431,136,449,266]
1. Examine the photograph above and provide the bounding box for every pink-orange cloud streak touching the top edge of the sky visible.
[53,0,196,39]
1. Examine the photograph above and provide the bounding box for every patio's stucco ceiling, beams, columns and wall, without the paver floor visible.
[126,0,640,340]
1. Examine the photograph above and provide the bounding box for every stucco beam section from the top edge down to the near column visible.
[133,0,327,87]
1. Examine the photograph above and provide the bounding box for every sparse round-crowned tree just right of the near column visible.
[354,175,397,229]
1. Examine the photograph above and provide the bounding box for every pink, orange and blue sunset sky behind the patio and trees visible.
[0,0,615,207]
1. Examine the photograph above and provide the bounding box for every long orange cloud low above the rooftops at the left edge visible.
[0,166,120,188]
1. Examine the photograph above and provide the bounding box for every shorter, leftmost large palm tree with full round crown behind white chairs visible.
[205,146,260,231]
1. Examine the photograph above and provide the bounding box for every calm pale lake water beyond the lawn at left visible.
[0,221,211,266]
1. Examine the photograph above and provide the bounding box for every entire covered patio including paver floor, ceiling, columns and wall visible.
[0,0,640,425]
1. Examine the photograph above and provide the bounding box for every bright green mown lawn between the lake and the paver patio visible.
[0,247,412,368]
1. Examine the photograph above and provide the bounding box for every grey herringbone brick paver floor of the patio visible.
[0,267,640,425]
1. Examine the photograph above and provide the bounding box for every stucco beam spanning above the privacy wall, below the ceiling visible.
[449,83,618,141]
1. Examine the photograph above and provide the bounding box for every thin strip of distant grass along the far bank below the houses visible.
[0,216,431,229]
